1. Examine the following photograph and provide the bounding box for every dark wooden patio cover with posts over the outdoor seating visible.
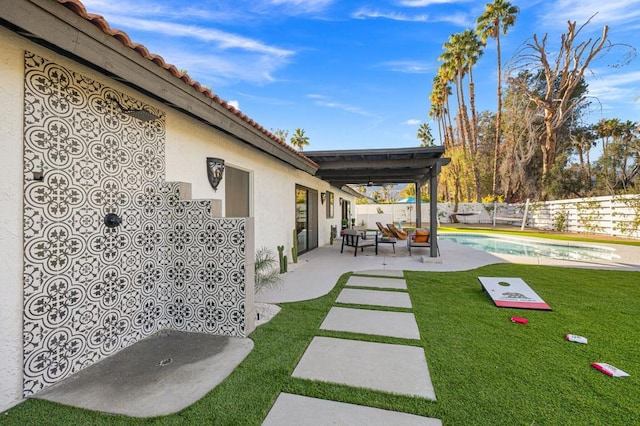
[304,146,450,257]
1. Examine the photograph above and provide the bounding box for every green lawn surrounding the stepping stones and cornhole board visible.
[5,264,640,425]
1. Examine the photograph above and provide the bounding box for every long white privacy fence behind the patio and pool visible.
[356,195,640,238]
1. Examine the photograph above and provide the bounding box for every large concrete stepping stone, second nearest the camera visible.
[292,336,436,400]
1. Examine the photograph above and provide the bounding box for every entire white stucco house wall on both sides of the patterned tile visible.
[0,23,354,412]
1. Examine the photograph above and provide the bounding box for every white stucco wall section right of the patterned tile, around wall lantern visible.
[166,111,353,257]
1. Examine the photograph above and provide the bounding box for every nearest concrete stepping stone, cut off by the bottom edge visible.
[262,393,442,426]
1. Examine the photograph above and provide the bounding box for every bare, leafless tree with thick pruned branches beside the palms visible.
[510,21,609,191]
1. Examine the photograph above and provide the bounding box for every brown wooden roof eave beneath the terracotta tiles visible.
[0,0,318,175]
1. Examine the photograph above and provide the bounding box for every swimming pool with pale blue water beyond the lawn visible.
[438,233,620,261]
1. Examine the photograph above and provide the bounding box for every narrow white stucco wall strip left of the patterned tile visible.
[0,28,24,411]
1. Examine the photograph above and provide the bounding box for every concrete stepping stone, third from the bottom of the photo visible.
[320,307,420,340]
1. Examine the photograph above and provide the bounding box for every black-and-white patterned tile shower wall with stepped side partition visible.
[24,52,253,396]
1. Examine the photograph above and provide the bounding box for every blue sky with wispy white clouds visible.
[83,0,640,150]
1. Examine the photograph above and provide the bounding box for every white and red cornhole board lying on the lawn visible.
[478,277,551,311]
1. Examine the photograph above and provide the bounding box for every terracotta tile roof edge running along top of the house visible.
[54,0,317,166]
